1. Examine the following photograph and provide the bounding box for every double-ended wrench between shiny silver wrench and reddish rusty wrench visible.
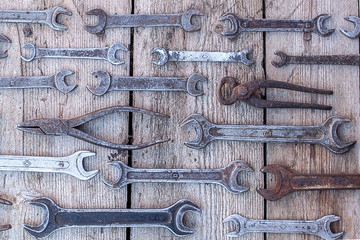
[104,160,253,194]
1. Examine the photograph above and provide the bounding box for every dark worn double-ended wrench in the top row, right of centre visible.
[219,13,335,40]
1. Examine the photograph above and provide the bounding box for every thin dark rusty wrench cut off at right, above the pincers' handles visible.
[271,51,360,68]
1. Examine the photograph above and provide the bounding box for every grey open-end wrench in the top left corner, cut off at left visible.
[0,6,72,31]
